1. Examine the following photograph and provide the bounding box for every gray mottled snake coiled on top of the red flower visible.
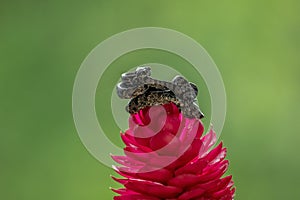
[117,67,204,119]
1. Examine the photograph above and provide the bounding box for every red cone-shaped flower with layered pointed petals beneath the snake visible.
[112,103,235,200]
